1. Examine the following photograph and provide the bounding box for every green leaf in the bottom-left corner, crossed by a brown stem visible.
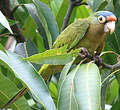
[0,73,31,110]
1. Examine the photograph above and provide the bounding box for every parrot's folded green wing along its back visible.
[53,19,89,50]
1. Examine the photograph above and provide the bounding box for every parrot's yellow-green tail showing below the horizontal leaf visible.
[39,64,64,80]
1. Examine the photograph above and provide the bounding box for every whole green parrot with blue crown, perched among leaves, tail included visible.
[39,11,117,80]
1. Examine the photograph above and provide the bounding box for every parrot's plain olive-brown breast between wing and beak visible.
[75,24,106,54]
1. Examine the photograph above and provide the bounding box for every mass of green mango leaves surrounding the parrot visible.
[0,0,120,110]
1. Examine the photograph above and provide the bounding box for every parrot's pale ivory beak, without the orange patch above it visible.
[104,21,115,34]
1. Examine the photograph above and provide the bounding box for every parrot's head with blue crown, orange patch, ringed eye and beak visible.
[91,11,117,34]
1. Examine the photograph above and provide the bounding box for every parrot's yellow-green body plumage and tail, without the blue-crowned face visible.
[39,12,109,80]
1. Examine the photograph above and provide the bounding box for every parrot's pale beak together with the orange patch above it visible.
[104,16,117,34]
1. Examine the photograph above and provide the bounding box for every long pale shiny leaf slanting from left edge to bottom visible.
[0,51,56,110]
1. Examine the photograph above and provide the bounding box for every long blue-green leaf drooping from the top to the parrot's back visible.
[34,0,59,42]
